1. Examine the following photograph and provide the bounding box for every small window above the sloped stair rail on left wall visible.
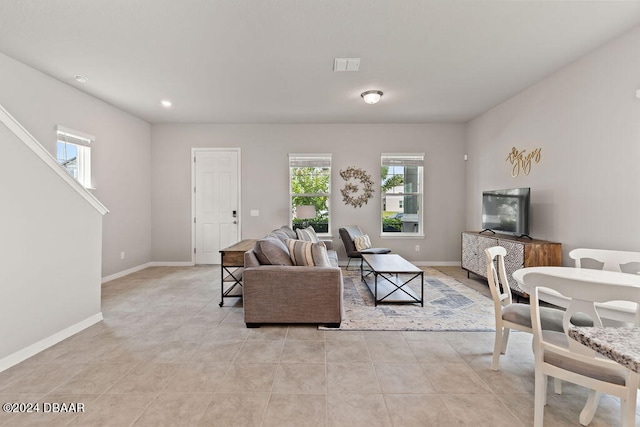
[56,126,95,188]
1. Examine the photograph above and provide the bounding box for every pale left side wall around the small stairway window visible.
[0,54,151,277]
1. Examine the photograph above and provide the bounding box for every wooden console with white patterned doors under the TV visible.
[462,231,562,297]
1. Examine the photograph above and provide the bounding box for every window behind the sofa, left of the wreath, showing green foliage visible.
[289,154,331,234]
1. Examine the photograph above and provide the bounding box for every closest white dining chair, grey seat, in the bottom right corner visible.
[523,273,640,427]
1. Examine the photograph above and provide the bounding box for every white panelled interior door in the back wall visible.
[194,150,240,264]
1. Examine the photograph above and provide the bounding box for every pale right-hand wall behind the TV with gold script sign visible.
[466,28,640,264]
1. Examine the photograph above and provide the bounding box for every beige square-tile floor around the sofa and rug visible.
[0,267,636,427]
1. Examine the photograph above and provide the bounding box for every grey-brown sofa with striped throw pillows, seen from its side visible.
[242,226,343,327]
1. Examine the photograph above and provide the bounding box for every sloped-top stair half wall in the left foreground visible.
[0,124,102,371]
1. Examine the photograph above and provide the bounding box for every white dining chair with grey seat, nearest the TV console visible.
[484,246,592,372]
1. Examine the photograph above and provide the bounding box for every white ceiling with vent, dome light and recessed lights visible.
[0,0,640,123]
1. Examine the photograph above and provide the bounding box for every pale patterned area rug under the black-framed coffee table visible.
[320,267,495,332]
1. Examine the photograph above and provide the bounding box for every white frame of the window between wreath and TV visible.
[380,153,424,238]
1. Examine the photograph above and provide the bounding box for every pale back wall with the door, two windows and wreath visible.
[151,124,465,263]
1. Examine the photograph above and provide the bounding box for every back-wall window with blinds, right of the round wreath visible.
[380,153,424,236]
